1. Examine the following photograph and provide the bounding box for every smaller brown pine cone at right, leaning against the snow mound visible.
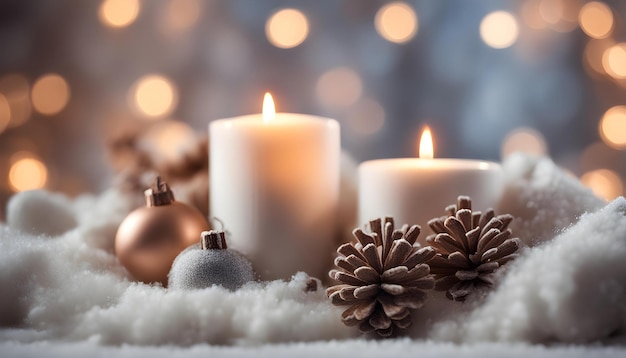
[426,196,521,301]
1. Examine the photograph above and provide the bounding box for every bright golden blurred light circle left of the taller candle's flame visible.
[131,74,178,118]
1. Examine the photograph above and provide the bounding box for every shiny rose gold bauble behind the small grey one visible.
[115,177,209,286]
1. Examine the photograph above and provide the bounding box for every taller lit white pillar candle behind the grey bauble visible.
[209,95,340,280]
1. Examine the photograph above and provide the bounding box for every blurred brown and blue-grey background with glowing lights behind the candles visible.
[0,0,626,218]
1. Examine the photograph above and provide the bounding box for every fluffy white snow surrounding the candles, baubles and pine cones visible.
[0,155,626,358]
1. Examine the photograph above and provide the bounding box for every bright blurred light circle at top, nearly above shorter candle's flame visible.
[374,2,418,43]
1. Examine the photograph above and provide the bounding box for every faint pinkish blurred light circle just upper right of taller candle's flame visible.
[316,67,363,107]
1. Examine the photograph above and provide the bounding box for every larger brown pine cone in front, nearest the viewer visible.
[326,218,435,337]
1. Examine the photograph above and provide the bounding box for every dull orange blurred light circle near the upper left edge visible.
[31,73,70,115]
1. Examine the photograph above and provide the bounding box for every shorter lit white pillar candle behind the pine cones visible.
[359,128,503,243]
